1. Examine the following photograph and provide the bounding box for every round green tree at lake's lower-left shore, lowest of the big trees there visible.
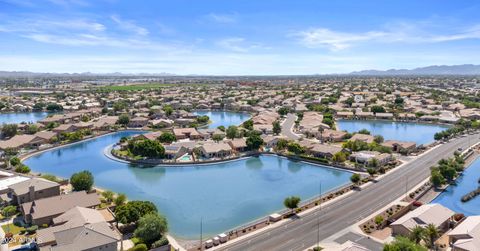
[134,213,168,245]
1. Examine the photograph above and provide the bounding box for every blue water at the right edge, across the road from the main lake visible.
[432,159,480,215]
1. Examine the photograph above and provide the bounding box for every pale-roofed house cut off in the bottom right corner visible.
[447,215,480,251]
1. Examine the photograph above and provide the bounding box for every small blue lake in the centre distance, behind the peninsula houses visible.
[194,111,250,128]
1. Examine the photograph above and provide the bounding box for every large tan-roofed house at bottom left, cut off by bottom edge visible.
[37,207,120,251]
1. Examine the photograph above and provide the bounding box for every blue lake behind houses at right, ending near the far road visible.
[337,120,449,145]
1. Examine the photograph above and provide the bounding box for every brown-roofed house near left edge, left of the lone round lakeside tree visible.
[9,178,60,205]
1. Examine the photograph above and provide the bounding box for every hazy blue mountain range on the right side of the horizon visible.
[349,64,480,76]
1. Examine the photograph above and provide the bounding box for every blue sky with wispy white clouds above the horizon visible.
[0,0,480,75]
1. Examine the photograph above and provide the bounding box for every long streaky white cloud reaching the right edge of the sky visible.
[293,22,480,51]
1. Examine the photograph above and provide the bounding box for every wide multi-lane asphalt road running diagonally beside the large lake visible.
[219,134,480,251]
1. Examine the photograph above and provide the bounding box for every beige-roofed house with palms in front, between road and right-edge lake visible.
[390,204,455,236]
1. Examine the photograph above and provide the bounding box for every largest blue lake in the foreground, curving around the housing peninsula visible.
[25,131,351,238]
